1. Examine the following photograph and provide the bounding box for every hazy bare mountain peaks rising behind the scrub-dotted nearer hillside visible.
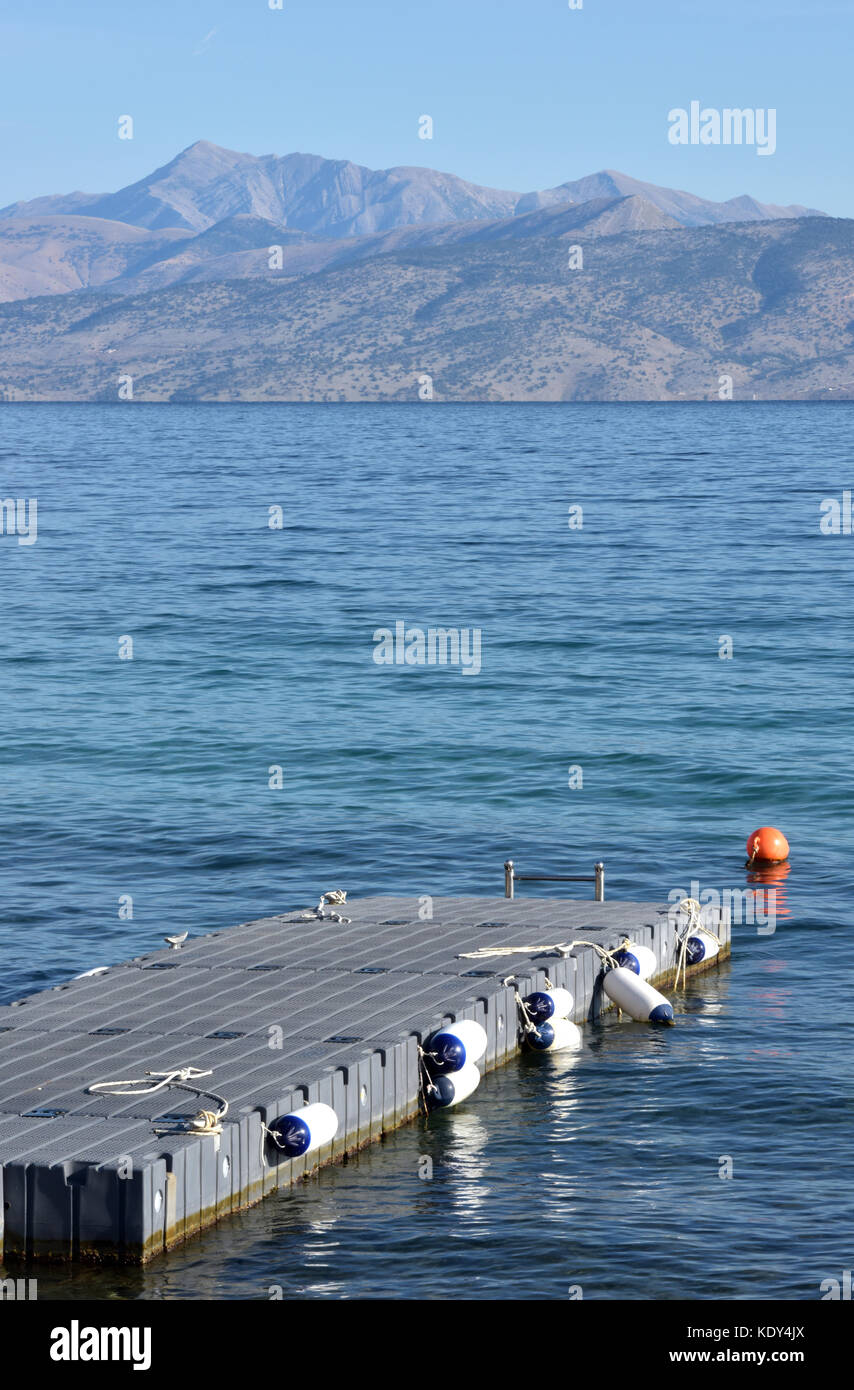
[0,140,823,300]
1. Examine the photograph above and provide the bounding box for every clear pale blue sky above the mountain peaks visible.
[0,0,854,217]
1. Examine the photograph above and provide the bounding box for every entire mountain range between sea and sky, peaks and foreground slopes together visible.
[0,142,854,402]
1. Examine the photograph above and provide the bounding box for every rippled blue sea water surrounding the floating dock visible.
[0,403,854,1300]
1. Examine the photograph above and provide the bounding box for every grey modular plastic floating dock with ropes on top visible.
[0,897,730,1262]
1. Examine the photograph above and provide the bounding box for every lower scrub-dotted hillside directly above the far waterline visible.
[0,214,854,409]
